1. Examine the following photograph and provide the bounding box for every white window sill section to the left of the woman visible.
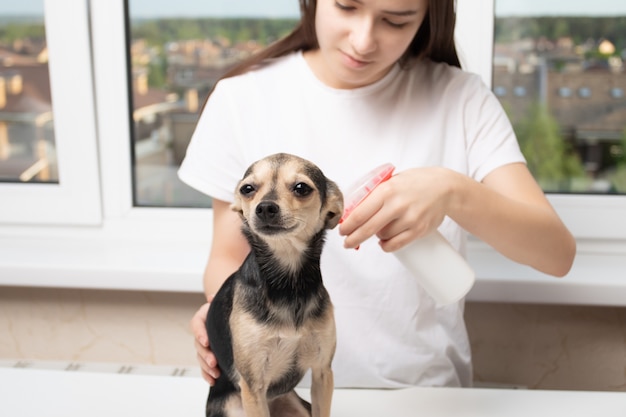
[0,209,212,292]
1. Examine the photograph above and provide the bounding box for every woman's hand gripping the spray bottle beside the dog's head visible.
[339,167,450,252]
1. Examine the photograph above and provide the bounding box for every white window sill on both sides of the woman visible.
[0,210,626,306]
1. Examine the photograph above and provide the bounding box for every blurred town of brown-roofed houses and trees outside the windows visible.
[0,13,626,206]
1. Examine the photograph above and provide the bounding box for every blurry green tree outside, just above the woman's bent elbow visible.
[515,103,585,191]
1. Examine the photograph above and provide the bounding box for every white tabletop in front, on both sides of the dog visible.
[0,368,626,417]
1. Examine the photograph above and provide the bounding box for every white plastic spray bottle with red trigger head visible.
[343,164,475,305]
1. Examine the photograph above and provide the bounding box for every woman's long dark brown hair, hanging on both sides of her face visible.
[209,0,461,95]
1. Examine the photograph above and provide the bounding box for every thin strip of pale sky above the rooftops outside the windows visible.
[0,0,626,17]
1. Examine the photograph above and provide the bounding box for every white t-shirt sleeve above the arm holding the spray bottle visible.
[464,76,526,181]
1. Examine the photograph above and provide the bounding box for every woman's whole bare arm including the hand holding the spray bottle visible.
[339,163,576,276]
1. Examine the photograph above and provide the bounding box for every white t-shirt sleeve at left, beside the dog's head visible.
[178,80,246,202]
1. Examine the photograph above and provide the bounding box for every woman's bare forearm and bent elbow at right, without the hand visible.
[450,163,576,276]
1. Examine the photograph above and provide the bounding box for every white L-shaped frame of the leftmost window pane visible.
[0,0,102,225]
